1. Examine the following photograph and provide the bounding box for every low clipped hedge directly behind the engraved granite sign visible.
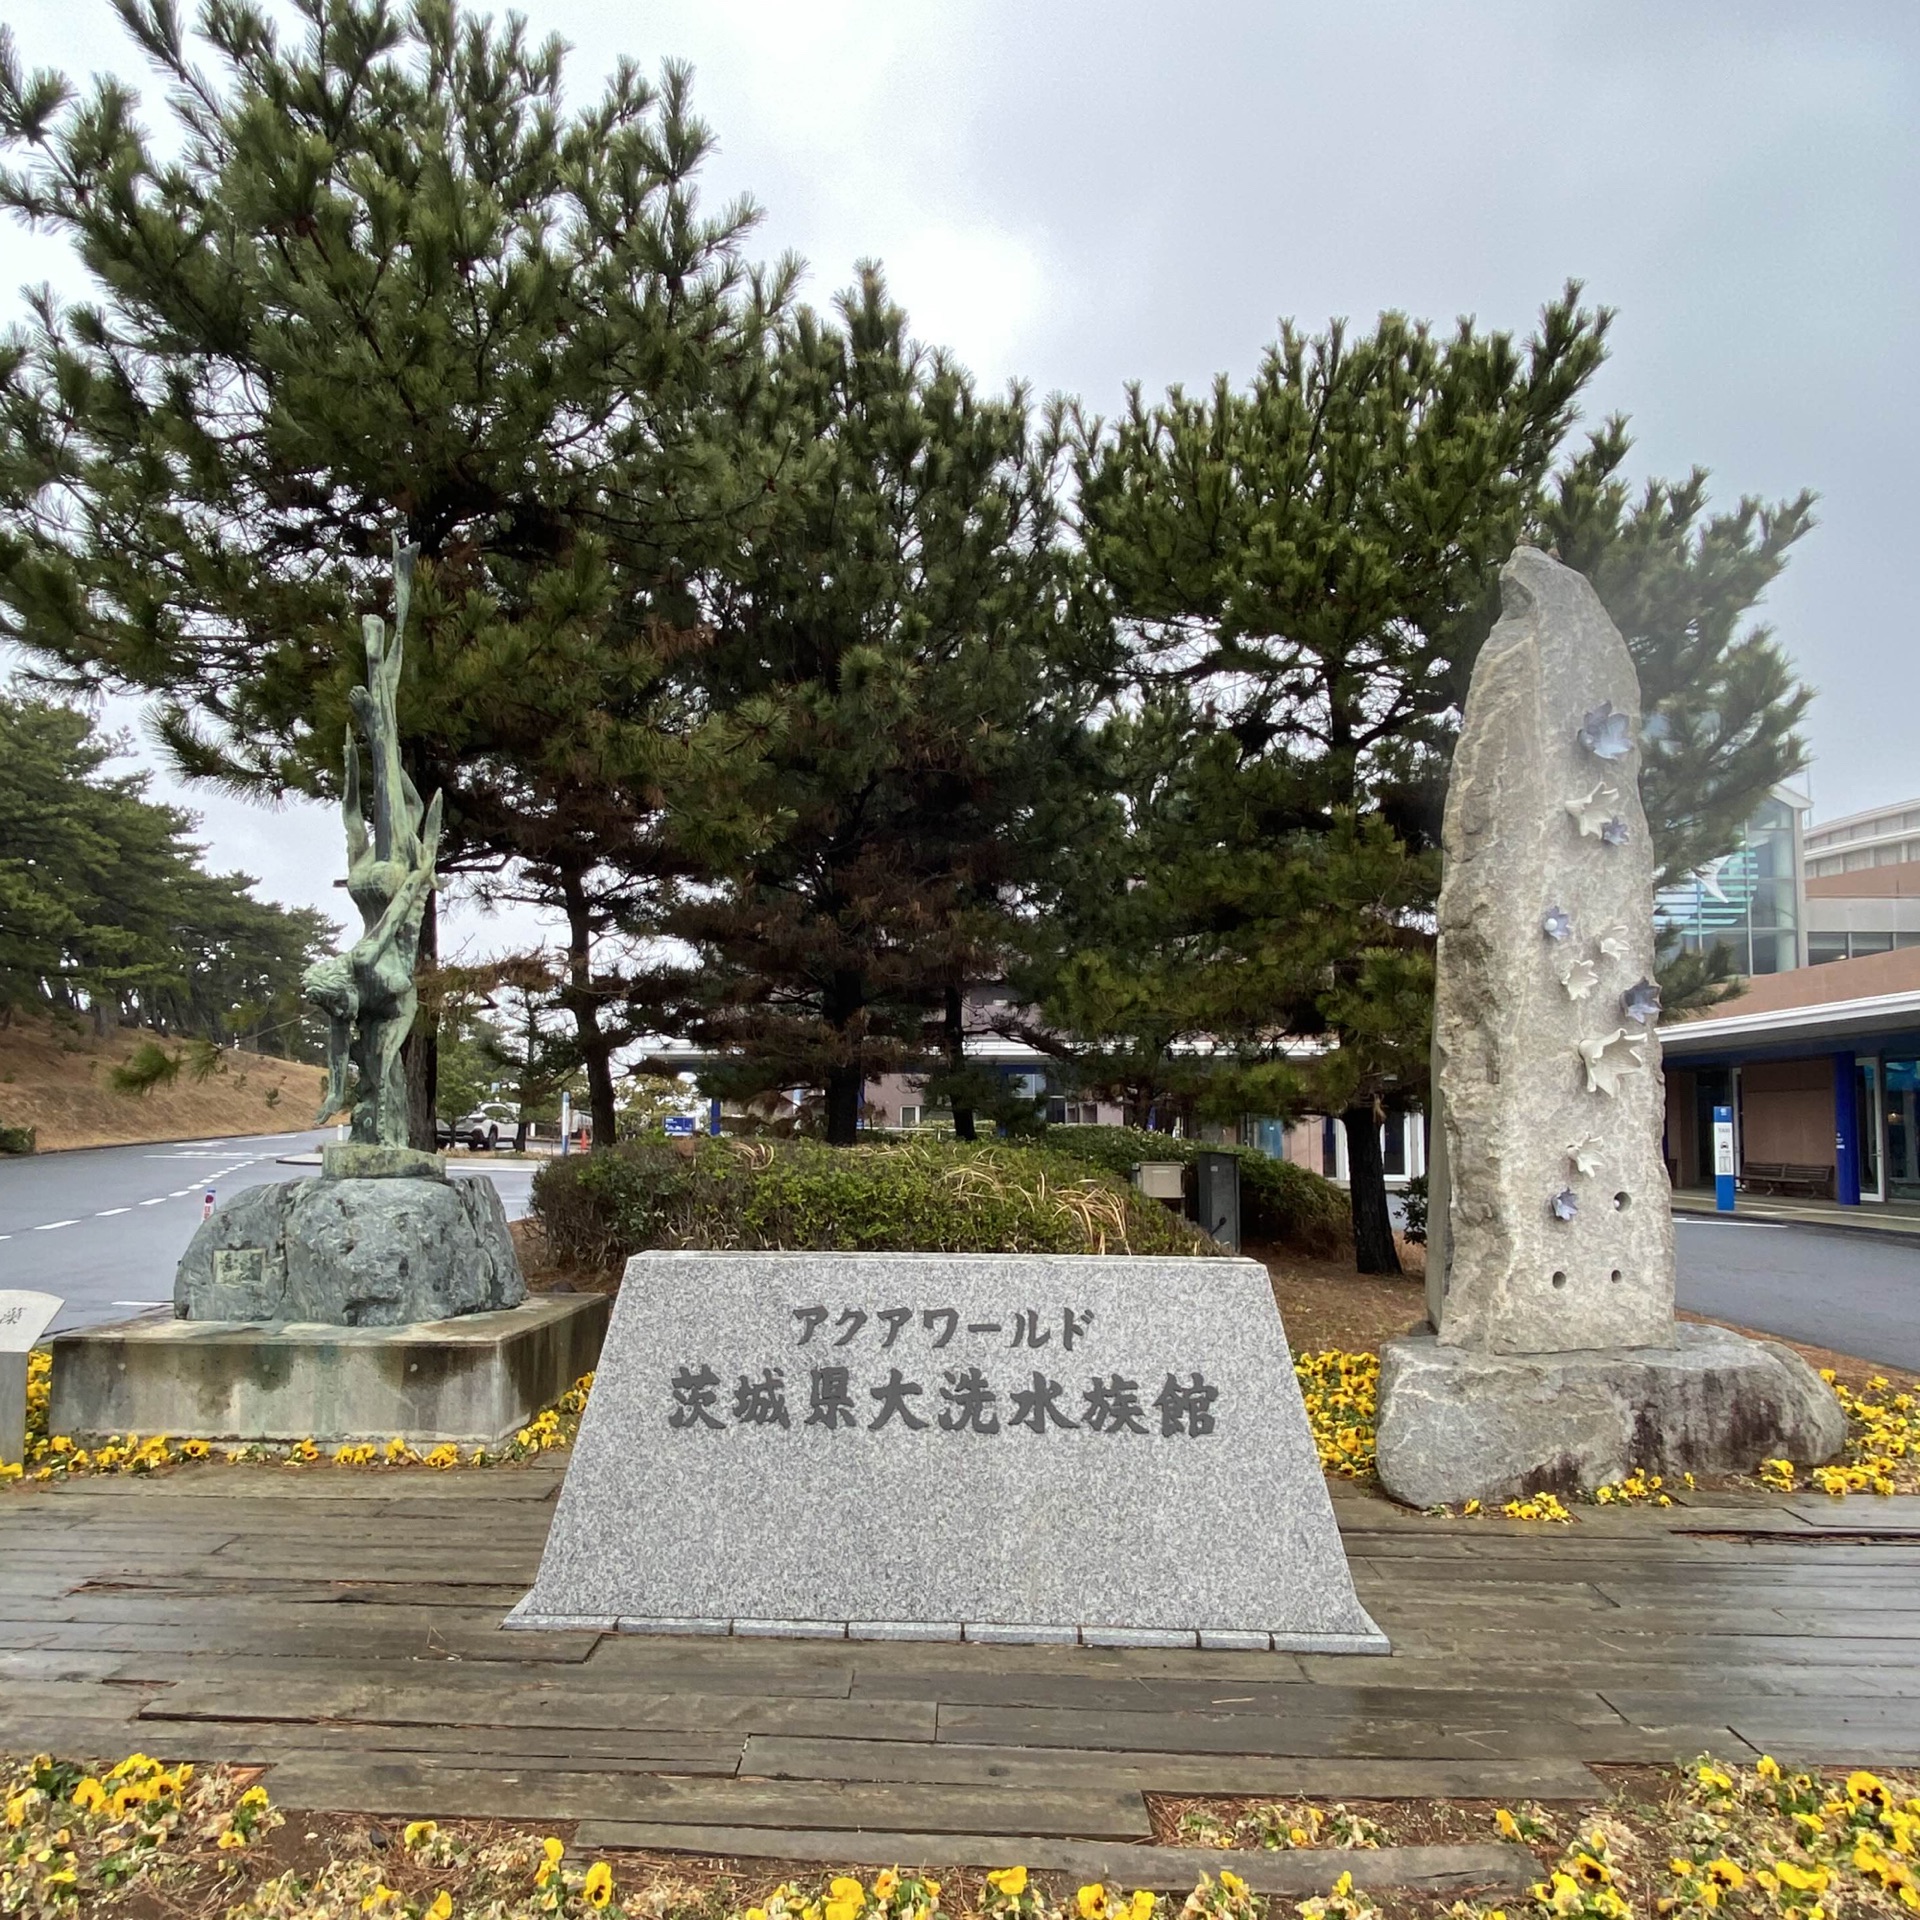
[532,1139,1217,1269]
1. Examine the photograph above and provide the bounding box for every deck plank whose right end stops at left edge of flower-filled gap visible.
[255,1755,1152,1839]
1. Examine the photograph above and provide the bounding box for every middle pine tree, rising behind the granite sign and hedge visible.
[668,269,1096,1144]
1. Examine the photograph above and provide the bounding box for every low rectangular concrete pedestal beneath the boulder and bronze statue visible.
[50,1294,609,1446]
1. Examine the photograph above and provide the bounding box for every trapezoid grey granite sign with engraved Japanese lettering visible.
[509,1254,1386,1653]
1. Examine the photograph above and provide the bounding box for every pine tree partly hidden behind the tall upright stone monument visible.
[1077,286,1811,1273]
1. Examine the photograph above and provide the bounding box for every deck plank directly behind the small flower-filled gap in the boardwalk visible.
[739,1734,1605,1801]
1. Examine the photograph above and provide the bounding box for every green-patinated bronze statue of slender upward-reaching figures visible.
[303,538,440,1146]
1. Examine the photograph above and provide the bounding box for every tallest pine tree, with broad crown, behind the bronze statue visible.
[0,0,791,1137]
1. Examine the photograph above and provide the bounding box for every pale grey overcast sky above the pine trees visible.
[0,0,1920,947]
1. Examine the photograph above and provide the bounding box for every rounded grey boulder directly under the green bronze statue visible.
[173,1177,526,1327]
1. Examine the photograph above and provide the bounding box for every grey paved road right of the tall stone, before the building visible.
[1674,1215,1920,1373]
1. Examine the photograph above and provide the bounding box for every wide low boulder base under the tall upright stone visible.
[1379,1323,1847,1507]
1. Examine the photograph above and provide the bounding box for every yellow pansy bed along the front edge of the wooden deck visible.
[0,1753,1920,1920]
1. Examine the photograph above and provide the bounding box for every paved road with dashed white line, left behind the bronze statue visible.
[0,1129,534,1329]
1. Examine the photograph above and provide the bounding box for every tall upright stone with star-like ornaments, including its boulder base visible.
[1379,547,1845,1505]
